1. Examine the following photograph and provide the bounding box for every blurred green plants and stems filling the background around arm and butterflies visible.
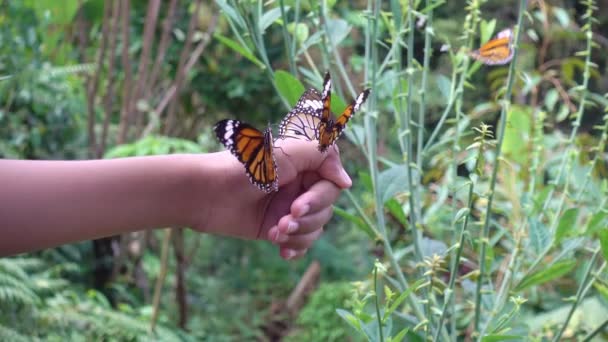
[0,0,608,341]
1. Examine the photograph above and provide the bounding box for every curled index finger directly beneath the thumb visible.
[291,180,341,218]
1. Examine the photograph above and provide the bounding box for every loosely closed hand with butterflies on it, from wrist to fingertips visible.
[195,139,352,259]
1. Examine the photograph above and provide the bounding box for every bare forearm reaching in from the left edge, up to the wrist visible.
[0,155,205,255]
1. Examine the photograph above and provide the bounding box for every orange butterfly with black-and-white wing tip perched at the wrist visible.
[213,120,279,193]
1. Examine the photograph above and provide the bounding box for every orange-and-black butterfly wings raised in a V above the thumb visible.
[318,73,370,152]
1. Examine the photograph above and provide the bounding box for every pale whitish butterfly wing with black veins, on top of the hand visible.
[279,88,323,141]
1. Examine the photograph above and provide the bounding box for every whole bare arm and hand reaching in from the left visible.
[0,139,352,259]
